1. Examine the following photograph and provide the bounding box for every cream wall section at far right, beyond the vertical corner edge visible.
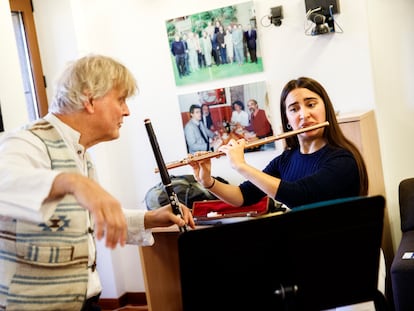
[367,0,414,251]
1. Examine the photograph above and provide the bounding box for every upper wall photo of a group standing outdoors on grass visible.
[166,1,263,86]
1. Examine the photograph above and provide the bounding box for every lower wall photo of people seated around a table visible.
[179,82,275,154]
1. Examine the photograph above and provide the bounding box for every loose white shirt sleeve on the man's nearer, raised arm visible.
[0,131,60,222]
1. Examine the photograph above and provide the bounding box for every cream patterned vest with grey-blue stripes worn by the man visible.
[0,120,94,311]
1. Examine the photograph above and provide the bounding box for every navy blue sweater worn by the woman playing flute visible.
[239,145,360,208]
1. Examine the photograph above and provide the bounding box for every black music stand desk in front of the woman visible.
[178,196,386,311]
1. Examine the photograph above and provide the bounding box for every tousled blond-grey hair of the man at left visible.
[49,55,138,114]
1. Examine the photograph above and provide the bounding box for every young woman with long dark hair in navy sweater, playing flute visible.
[188,77,368,208]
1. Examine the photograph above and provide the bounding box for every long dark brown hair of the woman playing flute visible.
[280,77,368,195]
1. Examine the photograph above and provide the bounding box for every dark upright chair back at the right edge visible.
[399,178,414,232]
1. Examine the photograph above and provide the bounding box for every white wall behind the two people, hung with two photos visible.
[0,0,414,298]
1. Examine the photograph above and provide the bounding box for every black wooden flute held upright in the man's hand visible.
[144,119,187,232]
